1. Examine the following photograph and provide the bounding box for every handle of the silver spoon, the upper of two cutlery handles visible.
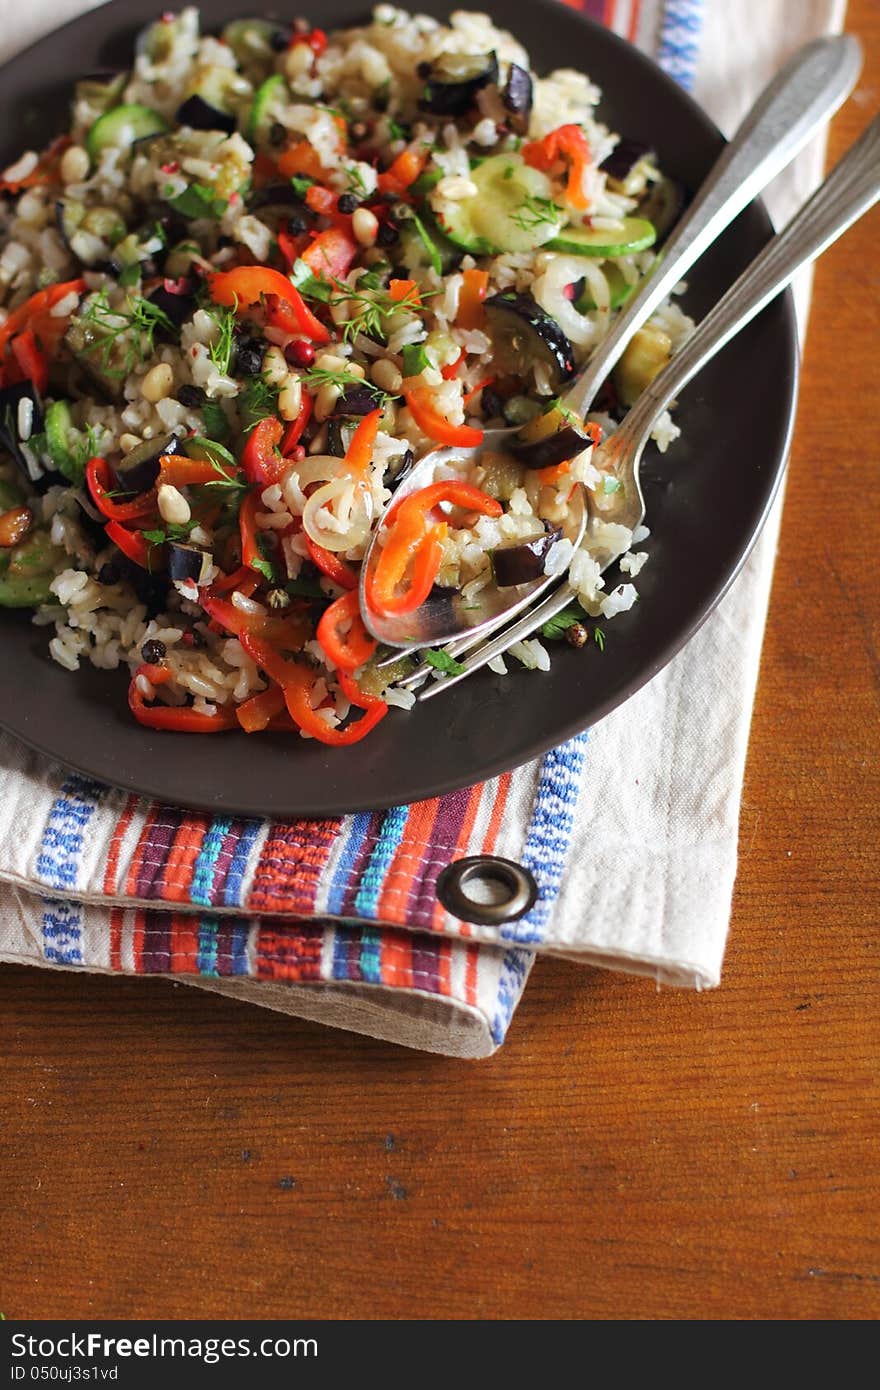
[564,35,862,414]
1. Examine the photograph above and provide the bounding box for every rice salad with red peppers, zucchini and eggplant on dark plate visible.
[0,4,692,745]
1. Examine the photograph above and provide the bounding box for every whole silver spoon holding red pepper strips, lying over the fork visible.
[360,35,862,659]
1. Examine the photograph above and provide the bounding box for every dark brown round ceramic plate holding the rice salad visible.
[0,0,797,816]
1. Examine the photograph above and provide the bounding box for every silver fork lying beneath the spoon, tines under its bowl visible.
[420,115,880,699]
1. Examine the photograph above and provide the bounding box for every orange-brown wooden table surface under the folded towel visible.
[0,0,880,1319]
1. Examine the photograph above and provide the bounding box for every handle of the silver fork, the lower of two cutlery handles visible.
[613,115,880,453]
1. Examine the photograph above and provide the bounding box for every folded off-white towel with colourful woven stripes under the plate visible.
[0,0,842,1056]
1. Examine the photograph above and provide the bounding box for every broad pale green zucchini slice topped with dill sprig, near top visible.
[430,154,563,256]
